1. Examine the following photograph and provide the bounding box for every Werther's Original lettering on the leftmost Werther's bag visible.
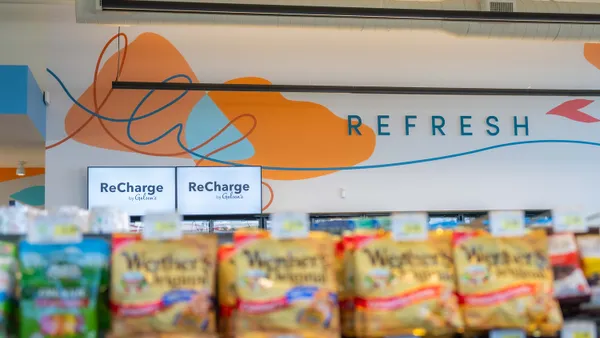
[121,252,210,288]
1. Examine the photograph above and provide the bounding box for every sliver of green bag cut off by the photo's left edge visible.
[0,242,17,337]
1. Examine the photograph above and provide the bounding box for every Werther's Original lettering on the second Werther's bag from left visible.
[242,250,327,284]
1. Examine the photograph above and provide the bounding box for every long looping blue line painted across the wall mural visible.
[46,68,600,171]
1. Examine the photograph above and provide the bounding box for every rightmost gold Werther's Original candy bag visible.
[453,230,562,335]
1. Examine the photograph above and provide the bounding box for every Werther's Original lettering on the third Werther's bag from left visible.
[363,248,454,282]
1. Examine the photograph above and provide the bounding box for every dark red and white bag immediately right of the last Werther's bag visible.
[549,233,591,302]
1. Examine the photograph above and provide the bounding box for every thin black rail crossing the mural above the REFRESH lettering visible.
[112,81,600,97]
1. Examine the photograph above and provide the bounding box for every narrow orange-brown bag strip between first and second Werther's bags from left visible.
[217,243,237,337]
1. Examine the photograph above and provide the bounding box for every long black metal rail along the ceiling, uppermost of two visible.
[102,0,600,24]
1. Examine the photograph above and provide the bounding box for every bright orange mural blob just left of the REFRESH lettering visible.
[206,78,375,180]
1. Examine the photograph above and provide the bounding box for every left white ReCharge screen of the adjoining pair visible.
[88,167,175,216]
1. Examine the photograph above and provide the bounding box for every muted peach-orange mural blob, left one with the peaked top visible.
[65,33,204,157]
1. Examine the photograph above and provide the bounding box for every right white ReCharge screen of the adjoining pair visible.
[177,167,262,215]
